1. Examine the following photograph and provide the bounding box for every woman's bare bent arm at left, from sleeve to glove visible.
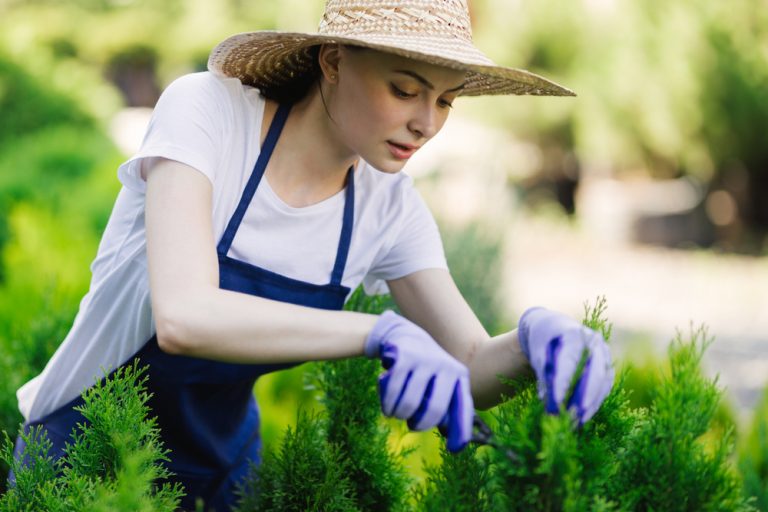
[142,158,378,363]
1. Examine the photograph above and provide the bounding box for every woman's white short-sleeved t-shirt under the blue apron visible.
[17,72,447,421]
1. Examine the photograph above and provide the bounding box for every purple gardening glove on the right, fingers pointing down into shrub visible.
[518,307,614,425]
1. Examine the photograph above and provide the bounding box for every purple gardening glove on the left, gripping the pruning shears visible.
[365,311,475,452]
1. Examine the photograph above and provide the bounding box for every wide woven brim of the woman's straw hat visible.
[208,31,576,96]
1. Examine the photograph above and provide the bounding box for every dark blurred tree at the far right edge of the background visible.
[701,1,768,251]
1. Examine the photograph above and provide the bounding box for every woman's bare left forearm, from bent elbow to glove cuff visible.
[155,289,378,363]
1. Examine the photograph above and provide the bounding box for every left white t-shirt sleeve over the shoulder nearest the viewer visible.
[117,73,231,192]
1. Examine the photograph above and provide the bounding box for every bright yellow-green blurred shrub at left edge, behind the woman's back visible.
[0,202,114,491]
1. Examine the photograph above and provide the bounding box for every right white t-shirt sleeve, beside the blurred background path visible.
[363,180,448,295]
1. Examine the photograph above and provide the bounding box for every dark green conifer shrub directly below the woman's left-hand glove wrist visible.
[238,288,410,512]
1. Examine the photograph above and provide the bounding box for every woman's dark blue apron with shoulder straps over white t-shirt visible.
[16,105,355,511]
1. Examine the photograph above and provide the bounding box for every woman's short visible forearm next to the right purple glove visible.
[469,329,533,409]
